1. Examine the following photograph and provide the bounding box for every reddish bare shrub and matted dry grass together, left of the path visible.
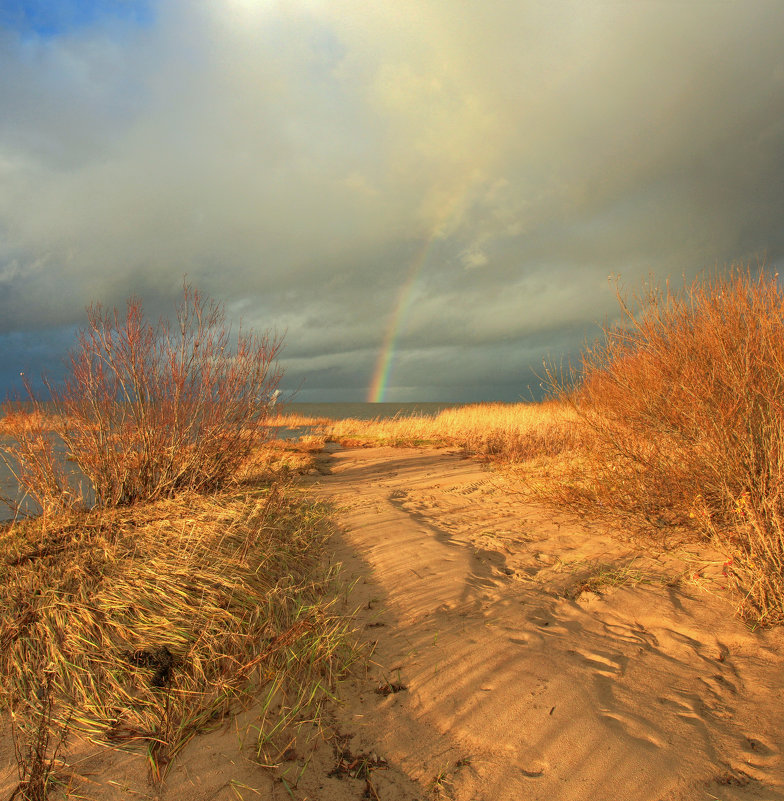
[0,286,361,801]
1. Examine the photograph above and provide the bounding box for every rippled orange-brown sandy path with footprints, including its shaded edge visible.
[0,448,784,801]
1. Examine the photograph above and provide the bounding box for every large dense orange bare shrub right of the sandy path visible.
[551,266,784,622]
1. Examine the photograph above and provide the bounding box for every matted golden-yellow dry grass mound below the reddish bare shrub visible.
[0,466,358,792]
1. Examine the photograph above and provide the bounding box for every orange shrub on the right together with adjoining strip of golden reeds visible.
[318,265,784,625]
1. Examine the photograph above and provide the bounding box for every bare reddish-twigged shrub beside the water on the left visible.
[5,285,281,511]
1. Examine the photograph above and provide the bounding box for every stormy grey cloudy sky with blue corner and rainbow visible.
[0,0,784,402]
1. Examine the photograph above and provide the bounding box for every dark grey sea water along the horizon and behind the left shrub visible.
[0,403,462,522]
